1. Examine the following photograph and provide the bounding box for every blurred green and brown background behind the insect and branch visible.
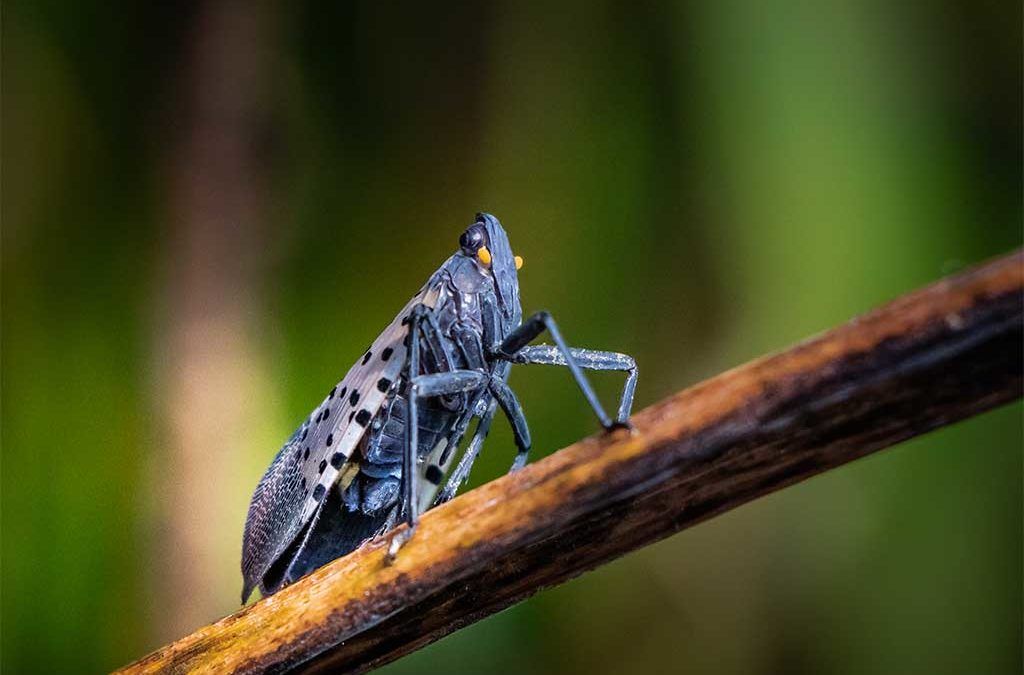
[2,0,1022,674]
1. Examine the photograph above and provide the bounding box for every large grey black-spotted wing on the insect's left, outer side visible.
[242,278,440,601]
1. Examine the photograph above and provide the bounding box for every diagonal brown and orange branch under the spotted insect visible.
[116,252,1024,672]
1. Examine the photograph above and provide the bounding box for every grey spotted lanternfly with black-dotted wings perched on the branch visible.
[242,213,637,602]
